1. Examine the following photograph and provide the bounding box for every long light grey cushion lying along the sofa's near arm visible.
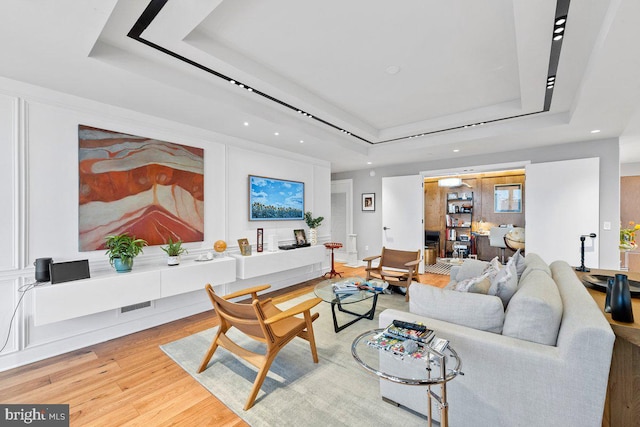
[409,283,504,334]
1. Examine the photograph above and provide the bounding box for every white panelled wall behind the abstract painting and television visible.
[0,78,331,370]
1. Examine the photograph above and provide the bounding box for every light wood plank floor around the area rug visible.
[0,265,449,427]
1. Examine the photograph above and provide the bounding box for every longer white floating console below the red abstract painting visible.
[34,257,236,326]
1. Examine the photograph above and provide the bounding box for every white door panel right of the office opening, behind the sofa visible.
[525,158,600,268]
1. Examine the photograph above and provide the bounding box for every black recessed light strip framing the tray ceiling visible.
[127,0,570,145]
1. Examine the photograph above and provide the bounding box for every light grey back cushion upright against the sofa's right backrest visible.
[502,270,563,345]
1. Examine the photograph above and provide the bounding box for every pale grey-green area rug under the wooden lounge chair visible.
[161,294,426,427]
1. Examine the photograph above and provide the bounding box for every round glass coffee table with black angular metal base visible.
[313,277,389,332]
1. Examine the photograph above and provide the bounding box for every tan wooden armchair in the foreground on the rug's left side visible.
[198,284,322,411]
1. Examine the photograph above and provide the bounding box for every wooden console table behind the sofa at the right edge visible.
[576,269,640,427]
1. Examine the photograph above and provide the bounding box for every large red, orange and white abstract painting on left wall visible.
[78,125,204,251]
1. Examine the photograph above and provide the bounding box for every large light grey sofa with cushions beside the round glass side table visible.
[380,254,615,427]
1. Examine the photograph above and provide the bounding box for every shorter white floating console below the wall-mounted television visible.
[231,245,326,279]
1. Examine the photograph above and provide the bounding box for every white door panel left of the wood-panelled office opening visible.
[380,175,424,273]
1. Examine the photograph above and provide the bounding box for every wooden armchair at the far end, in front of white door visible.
[363,246,420,301]
